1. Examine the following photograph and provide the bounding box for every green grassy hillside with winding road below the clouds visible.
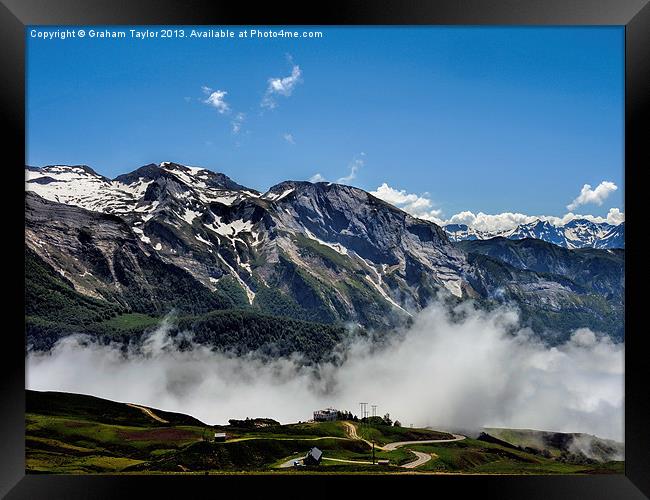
[25,391,623,474]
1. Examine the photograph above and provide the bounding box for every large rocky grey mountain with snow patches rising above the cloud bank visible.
[26,162,624,349]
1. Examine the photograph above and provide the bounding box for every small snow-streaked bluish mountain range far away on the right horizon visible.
[444,219,625,249]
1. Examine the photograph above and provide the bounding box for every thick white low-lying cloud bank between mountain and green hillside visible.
[27,303,624,441]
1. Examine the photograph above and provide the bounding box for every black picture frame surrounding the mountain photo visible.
[0,0,650,499]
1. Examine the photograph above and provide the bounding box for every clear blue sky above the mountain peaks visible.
[26,27,624,225]
